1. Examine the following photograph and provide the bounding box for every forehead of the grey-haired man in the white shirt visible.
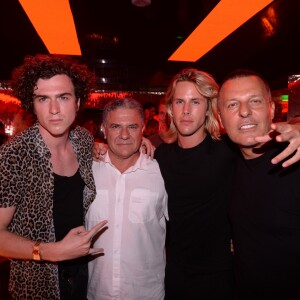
[107,108,142,124]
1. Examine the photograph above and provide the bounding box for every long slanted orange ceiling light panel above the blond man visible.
[169,0,273,62]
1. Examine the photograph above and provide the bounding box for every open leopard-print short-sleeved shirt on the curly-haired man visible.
[0,123,96,300]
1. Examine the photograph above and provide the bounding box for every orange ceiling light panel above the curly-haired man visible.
[19,0,81,55]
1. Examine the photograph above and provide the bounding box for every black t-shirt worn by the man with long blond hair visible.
[155,136,236,299]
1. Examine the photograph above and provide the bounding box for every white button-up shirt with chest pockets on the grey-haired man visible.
[86,153,168,300]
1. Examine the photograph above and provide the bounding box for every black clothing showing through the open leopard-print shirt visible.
[53,170,88,300]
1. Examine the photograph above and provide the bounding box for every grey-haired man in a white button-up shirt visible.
[86,99,167,300]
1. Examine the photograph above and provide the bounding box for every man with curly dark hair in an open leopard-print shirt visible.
[0,55,106,300]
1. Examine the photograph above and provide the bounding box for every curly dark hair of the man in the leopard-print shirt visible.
[11,54,96,112]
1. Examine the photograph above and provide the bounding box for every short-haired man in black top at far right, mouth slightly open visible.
[218,70,300,300]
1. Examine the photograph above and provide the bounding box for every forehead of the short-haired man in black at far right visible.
[220,76,268,100]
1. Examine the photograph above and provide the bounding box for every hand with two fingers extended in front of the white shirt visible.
[56,220,107,261]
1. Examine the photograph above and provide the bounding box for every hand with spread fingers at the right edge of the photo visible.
[255,123,300,168]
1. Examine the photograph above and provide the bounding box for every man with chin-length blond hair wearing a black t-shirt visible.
[155,69,299,300]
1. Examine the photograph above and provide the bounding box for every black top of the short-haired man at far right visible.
[230,145,300,300]
